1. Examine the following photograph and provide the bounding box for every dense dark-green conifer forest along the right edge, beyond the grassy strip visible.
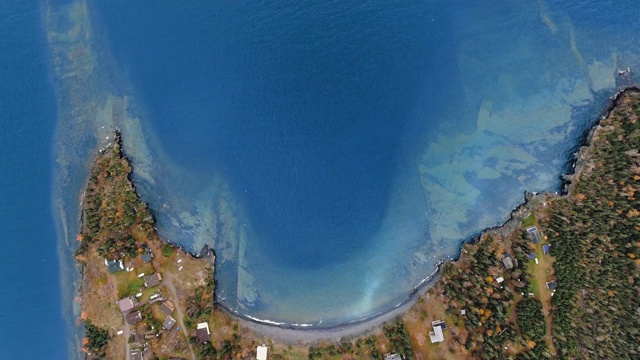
[544,90,640,359]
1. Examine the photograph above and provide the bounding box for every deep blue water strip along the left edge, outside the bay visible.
[0,1,68,359]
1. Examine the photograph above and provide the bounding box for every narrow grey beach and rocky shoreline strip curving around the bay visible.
[72,87,640,358]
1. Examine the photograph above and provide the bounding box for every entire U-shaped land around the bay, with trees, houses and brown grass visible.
[75,88,640,360]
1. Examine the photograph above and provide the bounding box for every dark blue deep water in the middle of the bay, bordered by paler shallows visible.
[95,2,453,268]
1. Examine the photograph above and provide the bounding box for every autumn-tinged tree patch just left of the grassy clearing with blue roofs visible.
[438,230,548,359]
